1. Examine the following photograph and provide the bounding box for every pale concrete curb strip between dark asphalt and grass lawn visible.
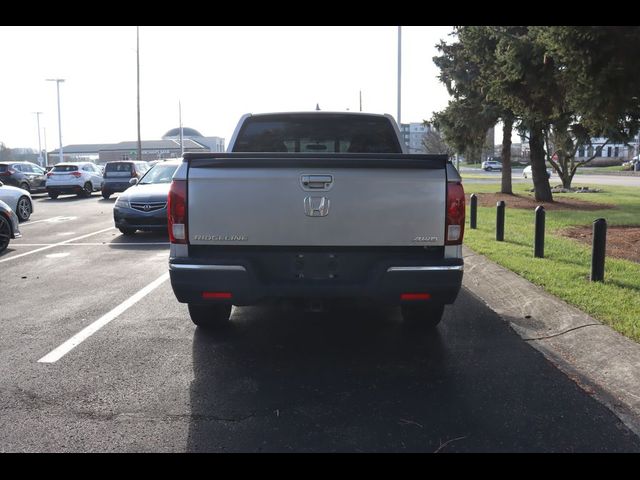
[462,247,640,436]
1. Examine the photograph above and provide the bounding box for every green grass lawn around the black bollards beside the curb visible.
[464,183,640,342]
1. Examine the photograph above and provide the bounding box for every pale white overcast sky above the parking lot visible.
[0,26,452,151]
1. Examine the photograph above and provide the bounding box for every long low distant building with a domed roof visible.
[48,127,225,165]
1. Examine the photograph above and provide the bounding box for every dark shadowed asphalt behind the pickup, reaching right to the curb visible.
[185,289,640,452]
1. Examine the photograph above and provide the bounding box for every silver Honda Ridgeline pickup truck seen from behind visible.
[168,112,465,327]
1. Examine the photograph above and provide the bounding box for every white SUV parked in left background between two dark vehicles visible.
[47,162,103,199]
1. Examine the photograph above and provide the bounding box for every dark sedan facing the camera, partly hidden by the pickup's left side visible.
[113,159,182,235]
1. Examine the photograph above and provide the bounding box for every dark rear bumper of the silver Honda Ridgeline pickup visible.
[169,251,464,305]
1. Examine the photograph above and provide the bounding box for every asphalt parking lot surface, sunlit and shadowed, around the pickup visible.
[0,191,640,452]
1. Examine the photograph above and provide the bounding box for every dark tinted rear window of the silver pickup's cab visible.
[233,114,402,154]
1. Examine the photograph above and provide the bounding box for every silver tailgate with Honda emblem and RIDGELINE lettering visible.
[187,154,447,246]
